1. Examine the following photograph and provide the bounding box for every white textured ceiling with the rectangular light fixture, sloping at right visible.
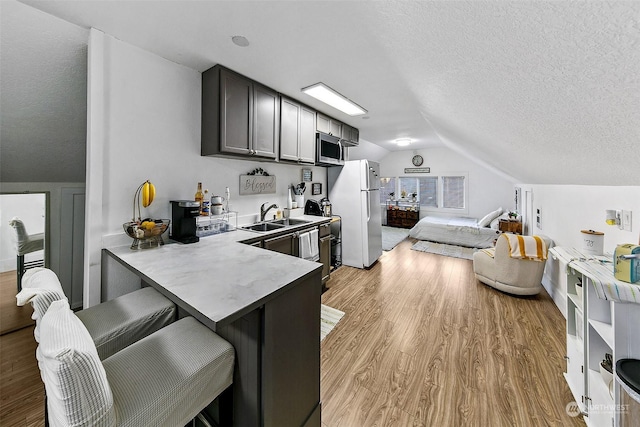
[3,0,640,185]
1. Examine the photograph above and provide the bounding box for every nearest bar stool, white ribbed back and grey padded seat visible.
[36,300,235,427]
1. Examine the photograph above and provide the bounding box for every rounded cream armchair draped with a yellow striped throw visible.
[473,235,553,295]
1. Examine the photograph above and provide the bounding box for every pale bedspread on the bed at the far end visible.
[409,216,500,248]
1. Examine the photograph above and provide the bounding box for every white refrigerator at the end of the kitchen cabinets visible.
[327,160,382,268]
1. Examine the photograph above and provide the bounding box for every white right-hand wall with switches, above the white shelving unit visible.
[529,185,640,313]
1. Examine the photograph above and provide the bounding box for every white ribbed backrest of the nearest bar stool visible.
[36,300,116,427]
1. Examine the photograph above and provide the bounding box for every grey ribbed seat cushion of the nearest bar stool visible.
[102,317,235,427]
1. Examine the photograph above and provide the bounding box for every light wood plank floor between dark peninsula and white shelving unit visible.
[321,240,584,427]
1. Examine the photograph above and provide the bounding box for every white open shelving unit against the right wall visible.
[550,247,640,427]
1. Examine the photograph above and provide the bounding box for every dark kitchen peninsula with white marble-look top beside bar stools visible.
[103,217,329,426]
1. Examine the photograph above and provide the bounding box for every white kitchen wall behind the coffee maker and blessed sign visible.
[85,30,327,306]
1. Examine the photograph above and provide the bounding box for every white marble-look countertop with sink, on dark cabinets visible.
[104,216,330,330]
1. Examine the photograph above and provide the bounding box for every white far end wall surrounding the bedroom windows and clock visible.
[380,148,515,218]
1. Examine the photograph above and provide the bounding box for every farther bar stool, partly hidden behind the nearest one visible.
[16,267,177,360]
